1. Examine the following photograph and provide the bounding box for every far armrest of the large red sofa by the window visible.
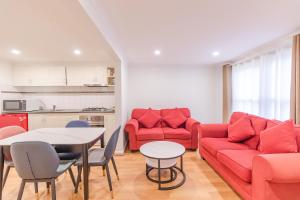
[198,124,228,138]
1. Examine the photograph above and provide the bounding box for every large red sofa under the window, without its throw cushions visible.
[198,112,300,200]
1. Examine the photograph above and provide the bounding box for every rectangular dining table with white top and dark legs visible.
[0,127,105,200]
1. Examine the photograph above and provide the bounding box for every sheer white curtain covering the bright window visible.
[232,47,292,120]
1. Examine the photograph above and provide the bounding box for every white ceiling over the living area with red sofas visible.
[80,0,300,64]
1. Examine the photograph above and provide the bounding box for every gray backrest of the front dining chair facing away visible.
[10,141,59,180]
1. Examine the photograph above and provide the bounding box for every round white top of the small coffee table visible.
[140,141,185,159]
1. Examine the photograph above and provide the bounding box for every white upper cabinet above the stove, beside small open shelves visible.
[67,66,107,86]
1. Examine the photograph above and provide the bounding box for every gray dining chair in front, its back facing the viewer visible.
[10,141,75,200]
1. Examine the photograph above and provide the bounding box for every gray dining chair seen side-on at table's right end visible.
[75,127,121,198]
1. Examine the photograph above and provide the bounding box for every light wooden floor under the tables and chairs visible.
[3,152,240,200]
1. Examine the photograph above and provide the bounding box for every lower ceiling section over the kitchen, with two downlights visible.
[0,0,118,62]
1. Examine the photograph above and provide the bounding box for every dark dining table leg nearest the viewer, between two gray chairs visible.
[82,144,89,200]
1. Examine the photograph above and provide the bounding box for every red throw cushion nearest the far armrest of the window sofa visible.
[228,116,255,142]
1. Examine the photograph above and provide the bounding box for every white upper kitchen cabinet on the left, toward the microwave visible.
[13,66,66,86]
